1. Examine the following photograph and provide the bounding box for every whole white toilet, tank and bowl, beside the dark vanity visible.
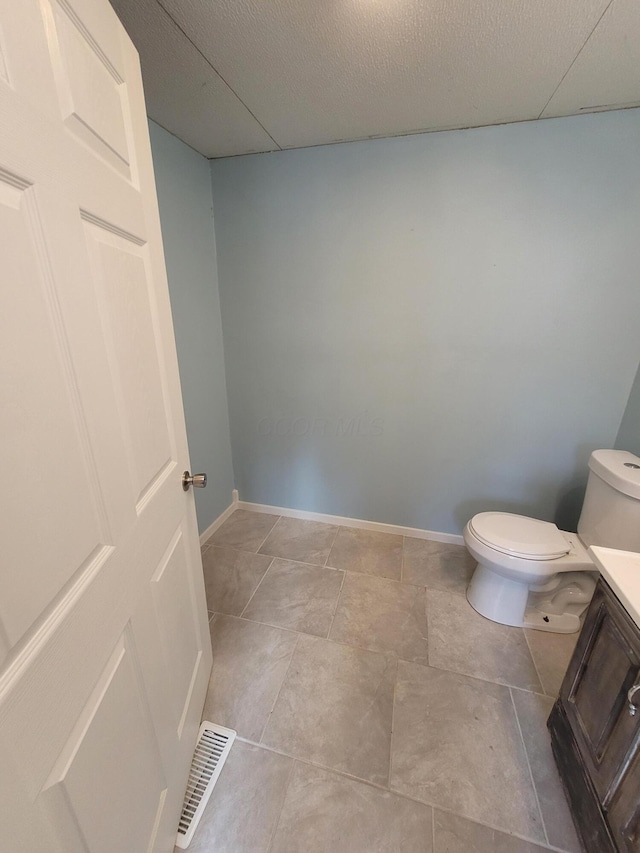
[464,450,640,634]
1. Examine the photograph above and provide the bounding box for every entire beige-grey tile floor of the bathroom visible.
[182,510,580,853]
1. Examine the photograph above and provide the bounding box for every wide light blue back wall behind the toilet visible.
[211,110,640,532]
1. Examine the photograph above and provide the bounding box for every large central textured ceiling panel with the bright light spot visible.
[162,0,608,147]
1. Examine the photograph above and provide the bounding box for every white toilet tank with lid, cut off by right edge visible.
[578,450,640,551]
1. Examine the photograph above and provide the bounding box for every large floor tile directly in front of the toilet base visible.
[427,589,541,692]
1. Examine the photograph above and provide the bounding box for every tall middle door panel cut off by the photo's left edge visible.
[0,173,110,647]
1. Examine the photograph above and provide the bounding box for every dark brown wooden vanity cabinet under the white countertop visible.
[549,578,640,853]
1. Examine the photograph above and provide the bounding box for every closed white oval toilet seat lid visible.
[469,512,570,560]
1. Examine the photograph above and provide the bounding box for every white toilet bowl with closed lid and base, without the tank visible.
[464,512,597,633]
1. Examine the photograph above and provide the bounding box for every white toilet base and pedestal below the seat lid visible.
[467,563,597,634]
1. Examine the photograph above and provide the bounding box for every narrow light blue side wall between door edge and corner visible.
[149,122,233,532]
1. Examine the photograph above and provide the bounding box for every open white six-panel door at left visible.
[0,0,211,853]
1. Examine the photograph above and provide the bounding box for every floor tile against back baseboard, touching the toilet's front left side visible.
[402,536,476,595]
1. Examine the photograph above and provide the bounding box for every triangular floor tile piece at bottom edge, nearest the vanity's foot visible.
[433,809,548,853]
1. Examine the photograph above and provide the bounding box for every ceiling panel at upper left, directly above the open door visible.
[112,0,277,157]
